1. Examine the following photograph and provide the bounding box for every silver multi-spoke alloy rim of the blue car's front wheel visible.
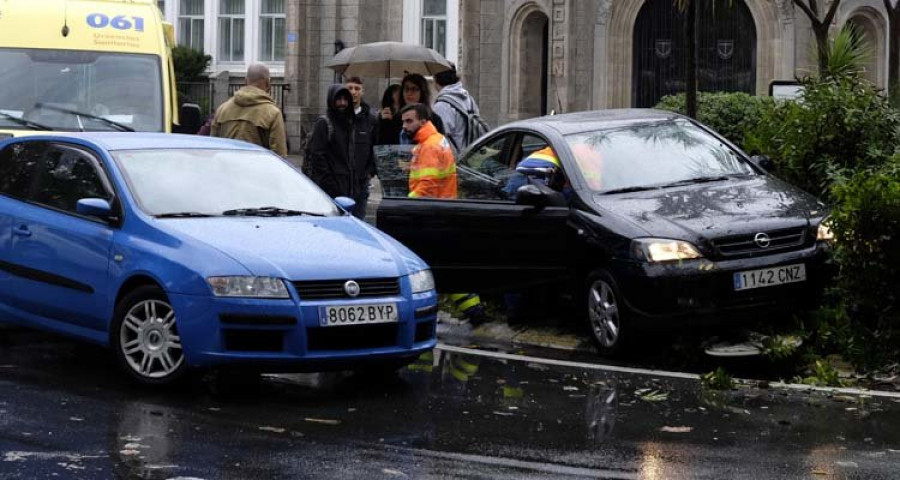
[119,299,184,379]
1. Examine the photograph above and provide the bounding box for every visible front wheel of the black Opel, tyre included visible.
[583,270,630,357]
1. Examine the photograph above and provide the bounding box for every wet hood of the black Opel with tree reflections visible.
[594,175,825,243]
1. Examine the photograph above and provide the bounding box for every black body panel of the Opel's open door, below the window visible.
[377,198,569,292]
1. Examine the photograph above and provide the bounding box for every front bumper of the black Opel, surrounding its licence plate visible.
[612,245,831,327]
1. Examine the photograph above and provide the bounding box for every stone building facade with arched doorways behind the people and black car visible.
[285,0,888,152]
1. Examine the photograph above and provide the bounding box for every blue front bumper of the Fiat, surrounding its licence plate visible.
[169,287,437,372]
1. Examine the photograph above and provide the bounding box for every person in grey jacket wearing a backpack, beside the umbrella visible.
[434,64,490,152]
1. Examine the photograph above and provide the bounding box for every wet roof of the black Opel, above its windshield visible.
[506,108,681,135]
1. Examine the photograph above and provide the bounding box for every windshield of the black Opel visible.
[566,120,754,192]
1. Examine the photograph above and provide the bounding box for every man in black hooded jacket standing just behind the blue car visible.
[304,84,375,218]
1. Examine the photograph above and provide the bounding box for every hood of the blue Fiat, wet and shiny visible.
[163,217,425,281]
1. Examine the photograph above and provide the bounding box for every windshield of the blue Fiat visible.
[114,149,340,216]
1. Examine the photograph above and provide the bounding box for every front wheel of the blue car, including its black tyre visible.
[110,285,187,386]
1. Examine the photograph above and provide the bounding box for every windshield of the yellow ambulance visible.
[0,48,164,132]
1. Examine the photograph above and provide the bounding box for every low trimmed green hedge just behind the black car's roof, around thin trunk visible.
[656,92,773,148]
